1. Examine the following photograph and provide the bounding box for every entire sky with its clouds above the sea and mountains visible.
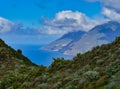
[0,0,120,45]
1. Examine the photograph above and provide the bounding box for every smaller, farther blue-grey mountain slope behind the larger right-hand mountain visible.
[41,31,85,51]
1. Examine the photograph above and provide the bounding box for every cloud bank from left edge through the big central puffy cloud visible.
[0,10,107,36]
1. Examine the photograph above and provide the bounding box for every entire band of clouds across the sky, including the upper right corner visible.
[0,0,120,35]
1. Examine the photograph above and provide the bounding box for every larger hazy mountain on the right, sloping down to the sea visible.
[42,21,120,55]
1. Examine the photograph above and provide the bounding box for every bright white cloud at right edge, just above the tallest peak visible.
[102,7,120,22]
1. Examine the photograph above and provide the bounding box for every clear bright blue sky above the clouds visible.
[0,0,101,26]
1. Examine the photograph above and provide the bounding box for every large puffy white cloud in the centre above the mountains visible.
[40,10,103,34]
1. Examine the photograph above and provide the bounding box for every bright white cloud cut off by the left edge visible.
[0,17,14,33]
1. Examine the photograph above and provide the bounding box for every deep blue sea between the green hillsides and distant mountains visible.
[11,44,72,66]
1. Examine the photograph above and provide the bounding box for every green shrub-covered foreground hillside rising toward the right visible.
[0,37,120,89]
